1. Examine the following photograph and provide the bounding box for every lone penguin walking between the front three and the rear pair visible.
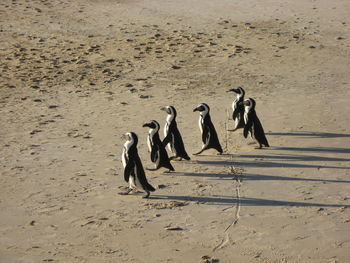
[193,103,222,155]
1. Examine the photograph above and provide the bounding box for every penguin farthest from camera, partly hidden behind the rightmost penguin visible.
[227,87,245,131]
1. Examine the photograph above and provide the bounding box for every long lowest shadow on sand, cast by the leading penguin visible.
[149,194,350,208]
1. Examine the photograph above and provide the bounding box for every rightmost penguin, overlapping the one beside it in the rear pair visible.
[242,98,270,149]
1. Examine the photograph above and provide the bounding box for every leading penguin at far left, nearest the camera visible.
[119,132,155,198]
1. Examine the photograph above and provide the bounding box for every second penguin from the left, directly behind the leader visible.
[142,120,175,172]
